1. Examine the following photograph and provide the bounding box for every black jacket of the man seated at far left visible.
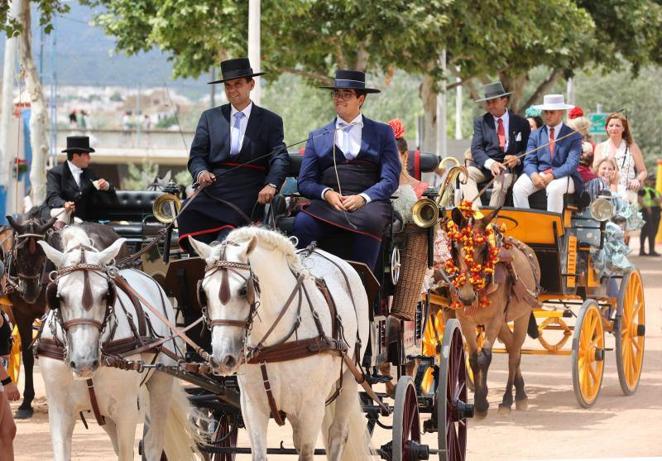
[46,161,117,221]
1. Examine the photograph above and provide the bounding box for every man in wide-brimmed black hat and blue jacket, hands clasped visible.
[294,70,401,270]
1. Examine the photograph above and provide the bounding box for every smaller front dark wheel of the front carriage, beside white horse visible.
[391,376,429,461]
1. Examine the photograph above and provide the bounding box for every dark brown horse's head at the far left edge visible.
[7,216,55,304]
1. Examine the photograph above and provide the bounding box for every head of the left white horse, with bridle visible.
[38,227,125,378]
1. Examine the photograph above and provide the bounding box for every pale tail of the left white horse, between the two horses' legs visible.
[164,382,202,460]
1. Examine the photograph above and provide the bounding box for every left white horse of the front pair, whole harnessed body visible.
[39,226,194,461]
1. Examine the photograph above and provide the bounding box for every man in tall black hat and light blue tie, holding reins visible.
[178,58,289,251]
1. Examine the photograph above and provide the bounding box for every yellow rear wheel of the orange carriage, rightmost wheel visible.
[614,271,646,395]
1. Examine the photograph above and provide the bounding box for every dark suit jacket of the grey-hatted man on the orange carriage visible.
[471,110,531,170]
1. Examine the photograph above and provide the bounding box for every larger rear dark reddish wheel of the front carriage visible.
[436,319,473,461]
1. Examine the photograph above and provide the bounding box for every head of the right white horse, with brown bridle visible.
[189,237,259,375]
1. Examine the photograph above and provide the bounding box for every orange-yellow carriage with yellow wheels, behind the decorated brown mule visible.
[432,174,646,408]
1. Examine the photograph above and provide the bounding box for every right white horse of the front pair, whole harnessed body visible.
[190,227,371,461]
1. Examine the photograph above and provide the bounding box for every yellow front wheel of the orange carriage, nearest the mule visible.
[572,299,605,408]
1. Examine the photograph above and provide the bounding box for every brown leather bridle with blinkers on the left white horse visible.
[46,245,117,332]
